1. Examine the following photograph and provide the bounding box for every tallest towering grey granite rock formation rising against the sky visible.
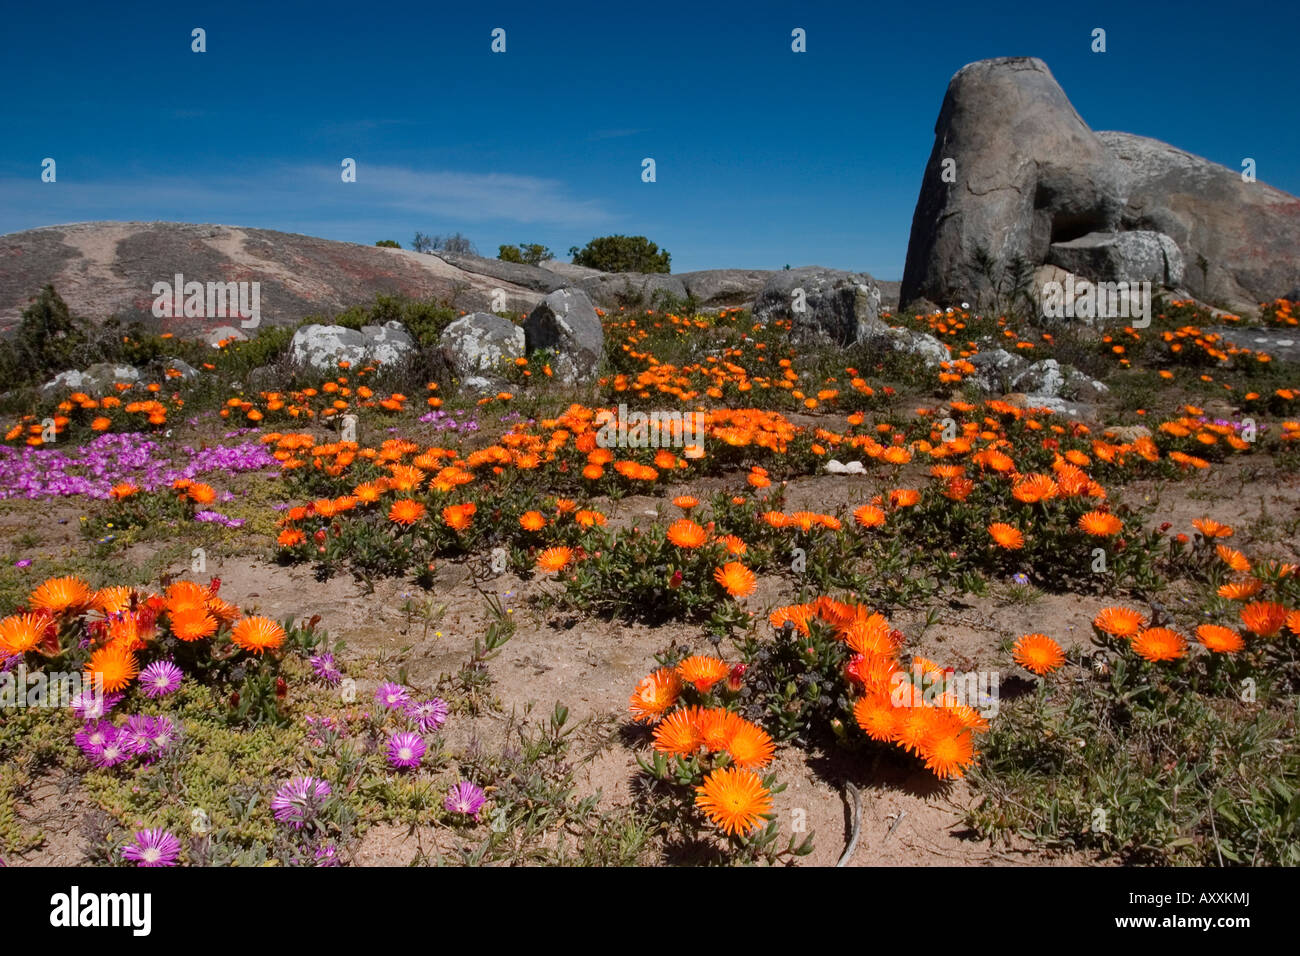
[900,57,1300,311]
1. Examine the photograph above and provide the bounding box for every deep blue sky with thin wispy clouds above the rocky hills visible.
[0,0,1300,278]
